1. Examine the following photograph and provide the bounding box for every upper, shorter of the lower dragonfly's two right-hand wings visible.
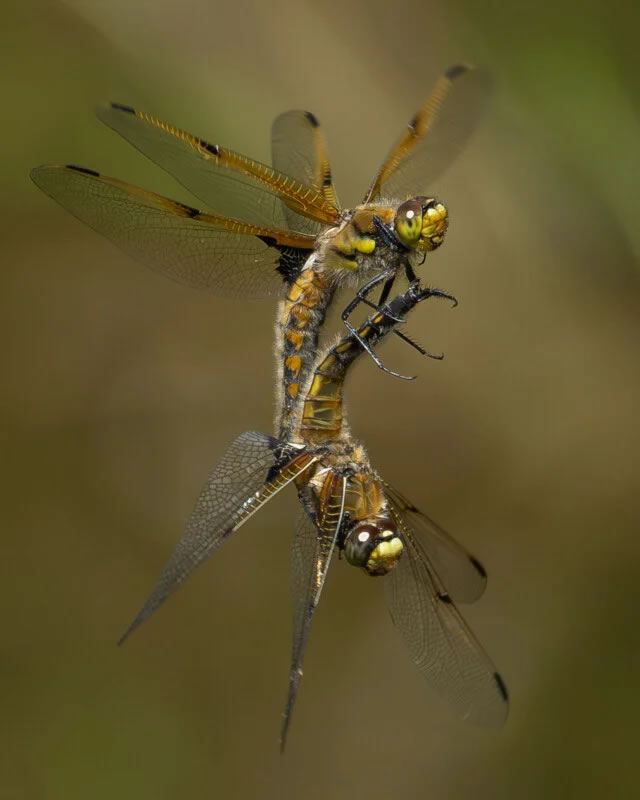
[378,476,487,603]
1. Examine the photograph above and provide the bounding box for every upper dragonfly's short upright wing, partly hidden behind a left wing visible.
[271,111,339,235]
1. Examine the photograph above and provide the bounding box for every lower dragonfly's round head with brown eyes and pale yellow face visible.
[344,517,403,575]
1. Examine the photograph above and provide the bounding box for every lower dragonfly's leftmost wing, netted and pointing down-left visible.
[120,431,315,643]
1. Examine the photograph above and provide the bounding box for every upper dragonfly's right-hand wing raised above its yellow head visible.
[364,64,493,202]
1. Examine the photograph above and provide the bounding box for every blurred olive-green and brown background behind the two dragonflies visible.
[0,0,640,800]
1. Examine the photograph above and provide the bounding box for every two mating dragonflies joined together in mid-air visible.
[32,66,508,746]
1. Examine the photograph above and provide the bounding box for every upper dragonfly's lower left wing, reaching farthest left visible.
[31,166,314,297]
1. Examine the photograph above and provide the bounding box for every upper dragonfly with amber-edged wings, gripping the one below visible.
[31,65,491,439]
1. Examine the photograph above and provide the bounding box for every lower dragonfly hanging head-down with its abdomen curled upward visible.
[116,281,508,749]
